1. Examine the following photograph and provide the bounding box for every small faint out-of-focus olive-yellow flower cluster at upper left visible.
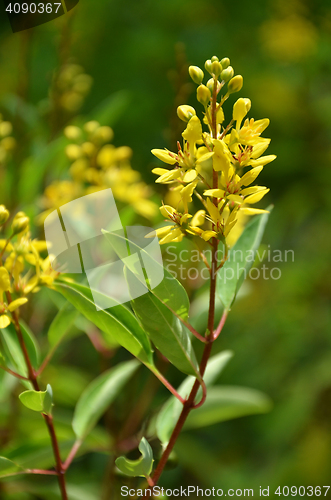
[50,63,93,113]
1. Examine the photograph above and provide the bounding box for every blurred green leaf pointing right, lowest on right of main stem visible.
[184,386,272,429]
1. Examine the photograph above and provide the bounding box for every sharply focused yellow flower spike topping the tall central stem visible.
[152,56,276,244]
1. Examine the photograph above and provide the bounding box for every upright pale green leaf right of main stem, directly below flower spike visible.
[216,207,272,309]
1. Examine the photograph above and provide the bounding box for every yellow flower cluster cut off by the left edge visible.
[0,205,59,328]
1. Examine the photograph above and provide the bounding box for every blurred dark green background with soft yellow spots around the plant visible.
[0,0,331,500]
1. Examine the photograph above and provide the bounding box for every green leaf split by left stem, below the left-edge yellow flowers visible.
[0,322,38,377]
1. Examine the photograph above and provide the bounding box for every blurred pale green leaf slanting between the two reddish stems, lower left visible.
[72,360,139,439]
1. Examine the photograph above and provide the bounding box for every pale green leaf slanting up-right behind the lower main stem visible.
[156,351,233,444]
